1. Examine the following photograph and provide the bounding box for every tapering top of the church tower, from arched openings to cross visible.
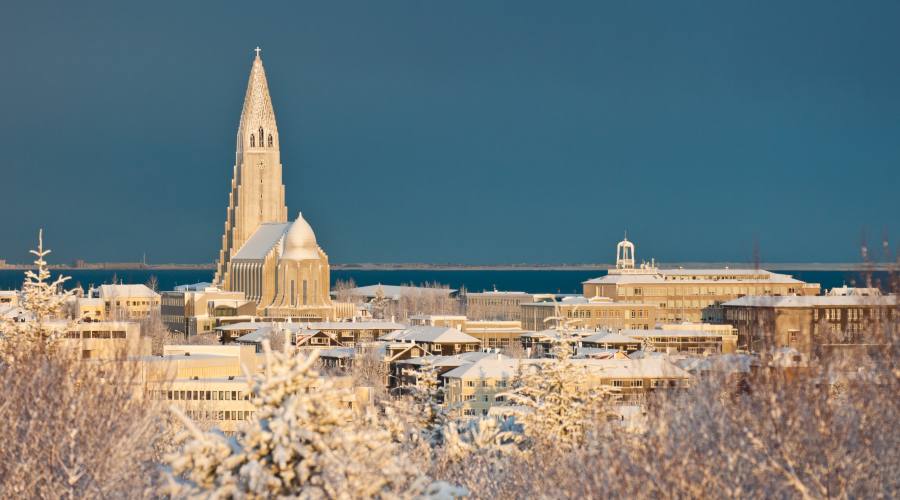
[237,47,278,154]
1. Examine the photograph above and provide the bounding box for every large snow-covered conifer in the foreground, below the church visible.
[169,343,460,498]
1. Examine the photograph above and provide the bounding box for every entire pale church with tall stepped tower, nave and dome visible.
[214,48,334,321]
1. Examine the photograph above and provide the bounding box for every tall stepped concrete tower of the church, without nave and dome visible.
[214,47,287,290]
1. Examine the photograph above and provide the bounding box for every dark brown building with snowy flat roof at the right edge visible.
[722,295,900,356]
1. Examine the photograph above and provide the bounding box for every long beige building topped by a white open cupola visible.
[583,238,819,323]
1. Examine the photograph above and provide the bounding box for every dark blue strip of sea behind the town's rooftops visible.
[0,269,888,294]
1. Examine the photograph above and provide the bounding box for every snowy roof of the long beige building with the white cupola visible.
[584,268,804,285]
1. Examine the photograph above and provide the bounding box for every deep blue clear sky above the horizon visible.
[0,0,900,263]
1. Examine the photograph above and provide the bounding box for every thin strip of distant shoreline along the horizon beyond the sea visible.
[0,262,897,272]
